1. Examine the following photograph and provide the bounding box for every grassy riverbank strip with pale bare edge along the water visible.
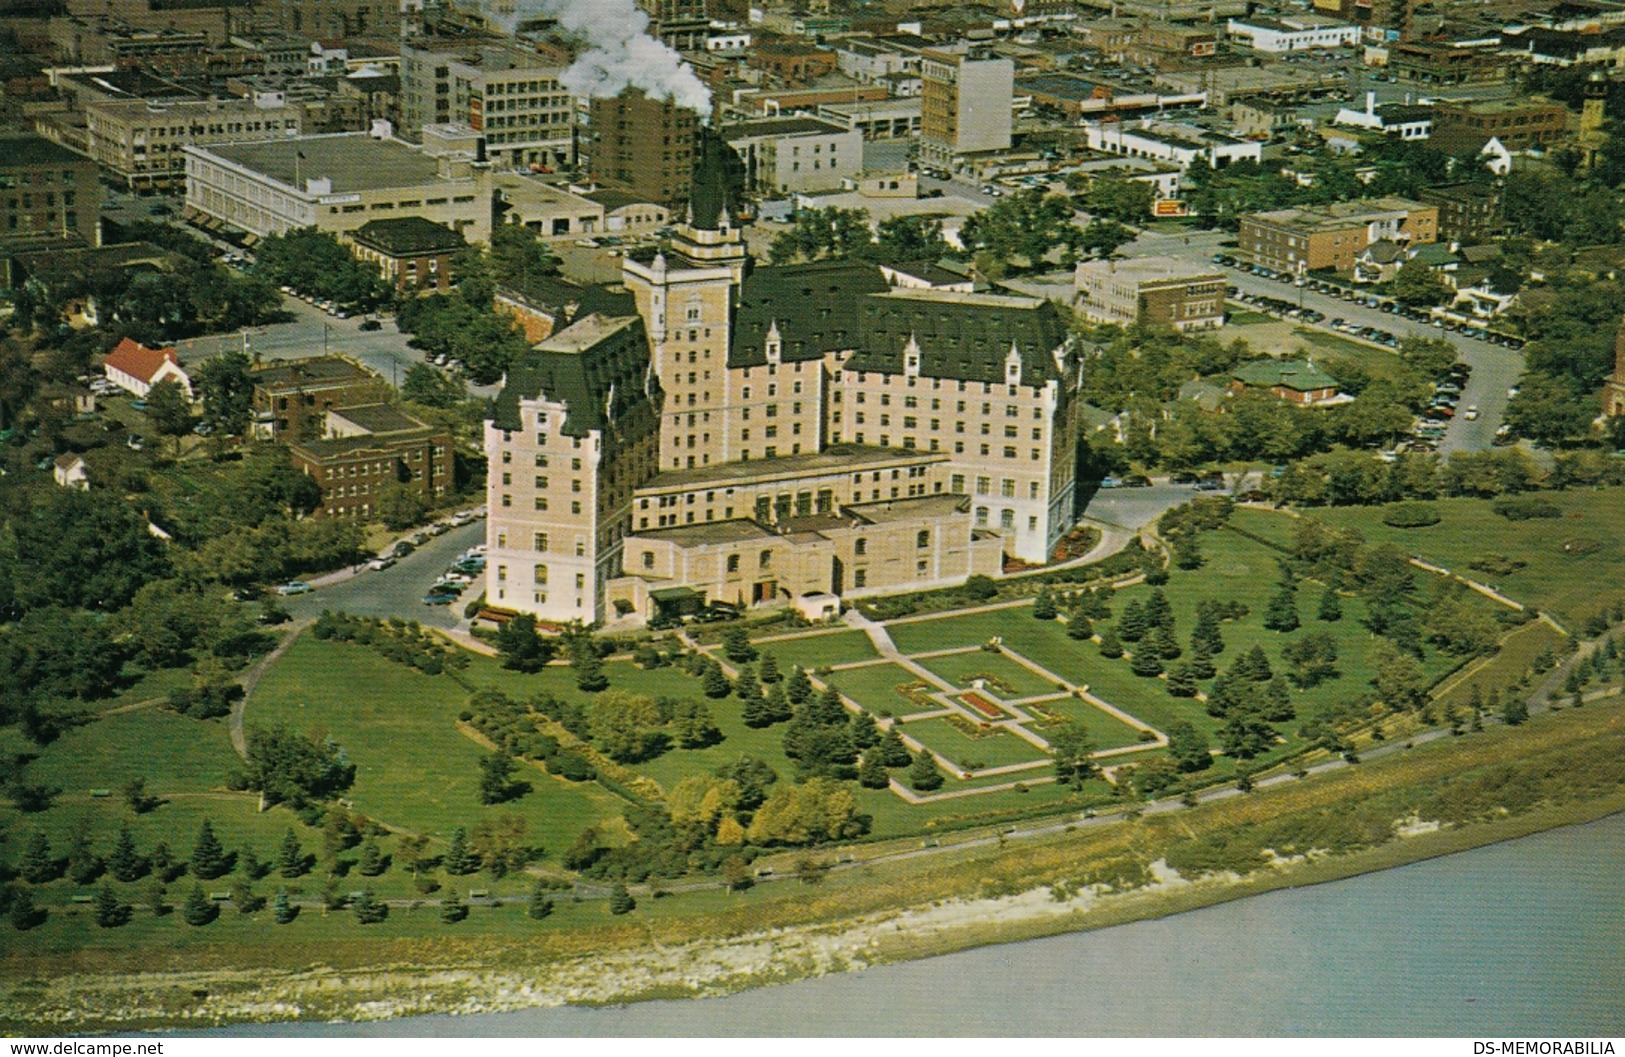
[9,695,1625,1033]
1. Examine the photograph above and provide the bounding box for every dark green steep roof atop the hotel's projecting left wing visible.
[492,315,660,437]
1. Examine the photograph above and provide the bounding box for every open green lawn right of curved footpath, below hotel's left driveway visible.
[249,637,627,859]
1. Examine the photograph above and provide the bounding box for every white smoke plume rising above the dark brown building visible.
[518,0,712,117]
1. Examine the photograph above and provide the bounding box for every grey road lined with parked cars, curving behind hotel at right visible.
[1123,231,1524,455]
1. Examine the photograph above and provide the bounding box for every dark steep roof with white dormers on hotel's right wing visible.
[845,289,1068,387]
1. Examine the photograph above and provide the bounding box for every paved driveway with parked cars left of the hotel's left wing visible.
[281,520,486,628]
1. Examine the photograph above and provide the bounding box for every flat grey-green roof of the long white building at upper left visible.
[202,132,452,194]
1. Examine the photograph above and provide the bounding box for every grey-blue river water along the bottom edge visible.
[208,815,1625,1037]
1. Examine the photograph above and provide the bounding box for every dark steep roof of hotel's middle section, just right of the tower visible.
[728,260,889,368]
